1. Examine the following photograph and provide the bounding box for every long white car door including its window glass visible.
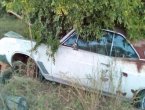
[55,32,113,90]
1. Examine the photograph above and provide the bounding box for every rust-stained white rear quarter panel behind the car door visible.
[113,58,145,98]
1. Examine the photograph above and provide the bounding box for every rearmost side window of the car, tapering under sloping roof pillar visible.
[111,34,138,58]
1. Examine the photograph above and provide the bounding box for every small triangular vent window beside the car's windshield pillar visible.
[63,34,77,47]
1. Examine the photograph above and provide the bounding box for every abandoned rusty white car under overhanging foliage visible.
[0,30,145,109]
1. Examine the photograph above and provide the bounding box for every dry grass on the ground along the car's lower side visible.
[0,76,134,110]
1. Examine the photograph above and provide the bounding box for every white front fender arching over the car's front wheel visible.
[0,37,54,78]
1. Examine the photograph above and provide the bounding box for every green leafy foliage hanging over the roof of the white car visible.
[1,0,145,54]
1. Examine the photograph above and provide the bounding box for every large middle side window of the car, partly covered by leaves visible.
[77,32,113,56]
